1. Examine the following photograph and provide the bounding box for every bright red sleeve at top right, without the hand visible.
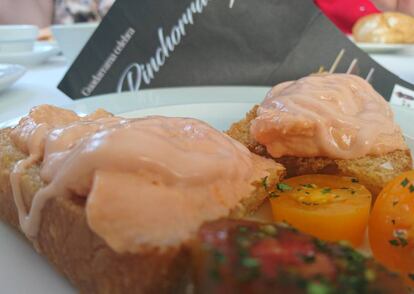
[315,0,380,34]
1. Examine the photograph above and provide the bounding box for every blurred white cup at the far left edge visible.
[0,25,39,54]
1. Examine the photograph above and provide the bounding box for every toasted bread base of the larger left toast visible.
[0,129,284,294]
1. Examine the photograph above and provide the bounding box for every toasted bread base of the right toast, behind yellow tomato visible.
[227,105,412,195]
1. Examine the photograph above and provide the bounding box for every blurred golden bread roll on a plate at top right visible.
[352,12,414,43]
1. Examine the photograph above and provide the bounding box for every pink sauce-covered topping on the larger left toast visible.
[11,106,275,252]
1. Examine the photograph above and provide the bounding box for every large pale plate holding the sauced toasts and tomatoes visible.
[0,87,414,294]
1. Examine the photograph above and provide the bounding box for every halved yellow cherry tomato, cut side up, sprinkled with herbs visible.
[270,175,371,246]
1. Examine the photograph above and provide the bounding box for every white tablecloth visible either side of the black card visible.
[0,54,414,122]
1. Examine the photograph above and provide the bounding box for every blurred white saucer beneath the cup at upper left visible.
[0,42,59,66]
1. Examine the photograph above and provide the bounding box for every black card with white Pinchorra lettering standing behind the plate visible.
[59,0,414,100]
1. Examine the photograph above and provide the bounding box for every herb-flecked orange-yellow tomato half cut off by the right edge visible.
[368,171,414,286]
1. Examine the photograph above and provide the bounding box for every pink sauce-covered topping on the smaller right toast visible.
[250,74,407,159]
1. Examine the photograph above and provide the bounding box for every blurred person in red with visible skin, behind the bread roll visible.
[315,0,414,34]
